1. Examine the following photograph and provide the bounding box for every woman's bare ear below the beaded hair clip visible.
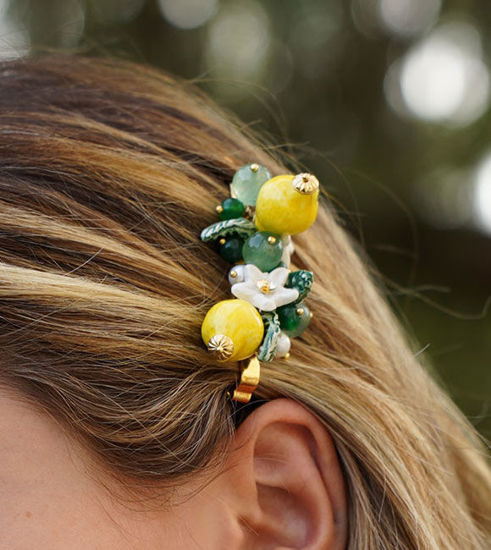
[222,399,347,550]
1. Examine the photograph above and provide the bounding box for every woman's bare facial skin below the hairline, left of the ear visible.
[0,394,232,550]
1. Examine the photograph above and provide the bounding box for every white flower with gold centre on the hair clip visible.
[231,264,298,311]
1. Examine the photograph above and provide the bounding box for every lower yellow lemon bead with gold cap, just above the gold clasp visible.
[201,298,264,361]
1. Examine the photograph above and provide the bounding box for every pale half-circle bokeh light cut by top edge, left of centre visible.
[158,0,218,29]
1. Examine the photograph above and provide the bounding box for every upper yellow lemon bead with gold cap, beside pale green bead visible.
[255,174,319,235]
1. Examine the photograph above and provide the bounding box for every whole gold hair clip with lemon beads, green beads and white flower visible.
[201,163,319,403]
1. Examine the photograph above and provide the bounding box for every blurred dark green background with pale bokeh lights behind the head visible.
[0,0,491,437]
